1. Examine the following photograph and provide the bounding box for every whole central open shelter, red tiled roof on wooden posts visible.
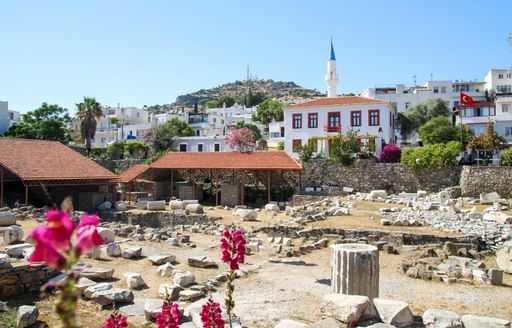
[150,151,302,205]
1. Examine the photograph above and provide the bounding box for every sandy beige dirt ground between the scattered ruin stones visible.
[4,202,512,328]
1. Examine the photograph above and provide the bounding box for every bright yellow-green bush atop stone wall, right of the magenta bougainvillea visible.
[401,141,460,169]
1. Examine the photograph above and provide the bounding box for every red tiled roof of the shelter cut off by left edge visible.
[0,138,117,181]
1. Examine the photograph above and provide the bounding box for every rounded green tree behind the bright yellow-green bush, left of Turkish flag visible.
[418,116,474,147]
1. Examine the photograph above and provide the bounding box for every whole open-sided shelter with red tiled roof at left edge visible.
[0,138,117,207]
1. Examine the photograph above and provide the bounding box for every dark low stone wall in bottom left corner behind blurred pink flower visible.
[0,261,60,299]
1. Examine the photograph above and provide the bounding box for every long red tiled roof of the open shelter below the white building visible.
[150,150,302,170]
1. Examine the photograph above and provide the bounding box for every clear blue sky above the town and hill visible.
[0,0,512,113]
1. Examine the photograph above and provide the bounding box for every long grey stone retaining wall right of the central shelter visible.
[301,159,461,195]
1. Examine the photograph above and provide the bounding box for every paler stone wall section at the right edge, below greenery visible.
[460,166,512,198]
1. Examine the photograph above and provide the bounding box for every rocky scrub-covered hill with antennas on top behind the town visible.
[172,80,322,108]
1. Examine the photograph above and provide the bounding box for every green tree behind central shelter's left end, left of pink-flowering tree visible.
[142,118,194,152]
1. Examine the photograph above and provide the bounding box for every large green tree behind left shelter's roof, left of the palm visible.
[5,103,71,143]
